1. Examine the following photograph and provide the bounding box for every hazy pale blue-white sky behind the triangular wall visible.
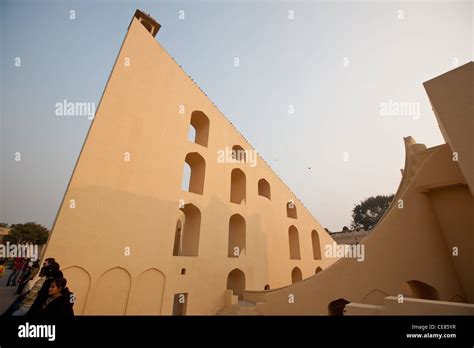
[0,0,474,231]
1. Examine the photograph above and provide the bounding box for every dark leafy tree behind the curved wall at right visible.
[351,194,394,231]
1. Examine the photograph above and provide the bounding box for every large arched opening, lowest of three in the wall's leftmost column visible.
[173,203,201,256]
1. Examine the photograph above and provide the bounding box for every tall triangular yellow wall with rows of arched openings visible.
[40,11,335,315]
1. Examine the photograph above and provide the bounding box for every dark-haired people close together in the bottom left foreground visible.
[3,258,75,320]
